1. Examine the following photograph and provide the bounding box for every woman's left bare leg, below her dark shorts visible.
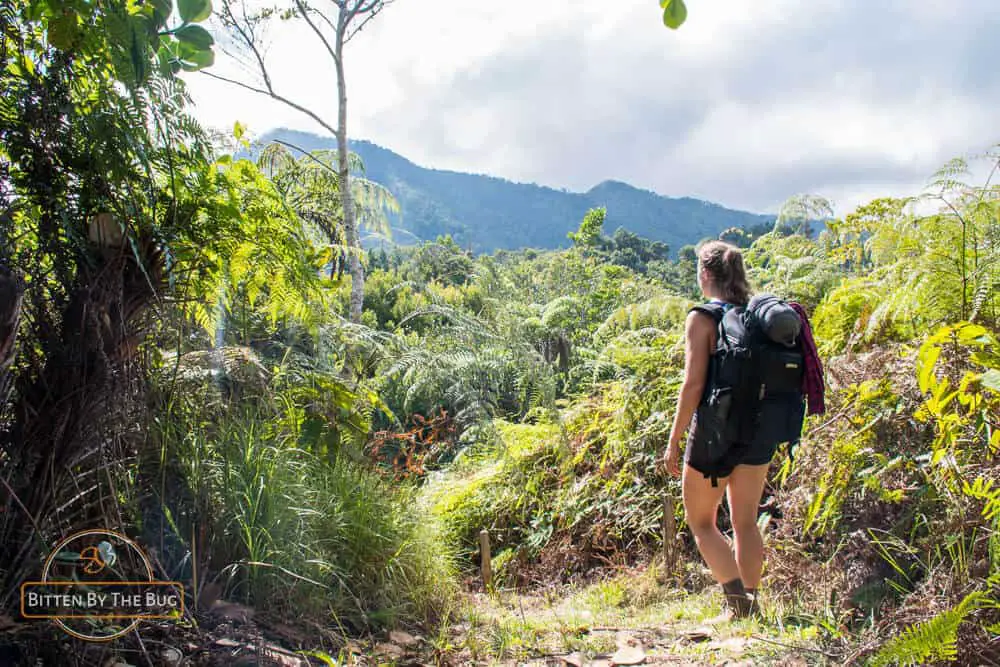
[682,466,740,584]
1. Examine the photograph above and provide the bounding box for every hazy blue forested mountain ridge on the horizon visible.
[261,129,774,253]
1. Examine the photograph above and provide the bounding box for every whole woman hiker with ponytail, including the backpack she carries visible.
[663,241,822,617]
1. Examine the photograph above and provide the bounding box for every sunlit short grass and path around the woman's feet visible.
[434,568,835,665]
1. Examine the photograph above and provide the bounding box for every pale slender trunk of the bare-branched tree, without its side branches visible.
[336,9,365,323]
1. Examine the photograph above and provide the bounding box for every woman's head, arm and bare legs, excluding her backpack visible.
[664,241,775,617]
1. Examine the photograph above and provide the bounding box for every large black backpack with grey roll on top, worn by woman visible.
[688,294,805,486]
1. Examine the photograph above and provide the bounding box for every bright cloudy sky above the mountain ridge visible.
[187,0,1000,215]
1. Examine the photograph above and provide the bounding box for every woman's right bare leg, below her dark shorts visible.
[728,465,768,589]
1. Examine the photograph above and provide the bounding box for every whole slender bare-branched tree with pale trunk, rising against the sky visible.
[214,0,393,322]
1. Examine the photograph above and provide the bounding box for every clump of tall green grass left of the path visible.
[146,376,455,629]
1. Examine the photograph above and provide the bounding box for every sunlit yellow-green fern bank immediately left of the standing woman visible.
[428,328,679,576]
